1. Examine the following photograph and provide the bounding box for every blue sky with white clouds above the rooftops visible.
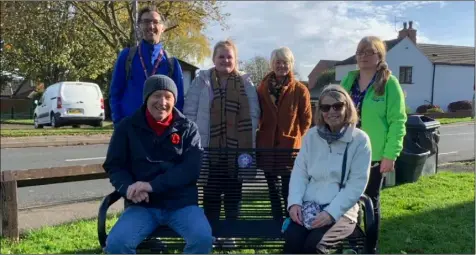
[199,1,475,80]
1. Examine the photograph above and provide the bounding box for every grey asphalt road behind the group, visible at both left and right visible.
[1,124,475,208]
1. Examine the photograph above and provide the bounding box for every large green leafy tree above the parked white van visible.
[1,1,115,85]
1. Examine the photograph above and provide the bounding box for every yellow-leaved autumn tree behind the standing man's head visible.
[72,1,228,64]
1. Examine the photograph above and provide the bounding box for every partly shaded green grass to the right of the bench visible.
[380,172,475,254]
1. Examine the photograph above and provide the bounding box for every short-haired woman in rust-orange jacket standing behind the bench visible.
[256,47,312,220]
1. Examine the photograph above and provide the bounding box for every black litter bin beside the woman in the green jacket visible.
[395,115,441,184]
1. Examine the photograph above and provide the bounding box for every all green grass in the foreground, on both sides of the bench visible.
[1,172,475,254]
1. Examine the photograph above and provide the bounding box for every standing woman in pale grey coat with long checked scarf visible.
[183,40,260,226]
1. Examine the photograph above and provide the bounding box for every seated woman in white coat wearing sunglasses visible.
[284,85,371,254]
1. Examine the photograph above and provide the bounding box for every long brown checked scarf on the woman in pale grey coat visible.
[209,69,253,148]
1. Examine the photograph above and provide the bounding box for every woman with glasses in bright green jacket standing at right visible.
[341,36,407,253]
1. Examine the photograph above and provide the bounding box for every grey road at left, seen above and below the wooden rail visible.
[1,144,113,208]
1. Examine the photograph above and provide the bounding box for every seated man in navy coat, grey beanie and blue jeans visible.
[103,75,213,254]
